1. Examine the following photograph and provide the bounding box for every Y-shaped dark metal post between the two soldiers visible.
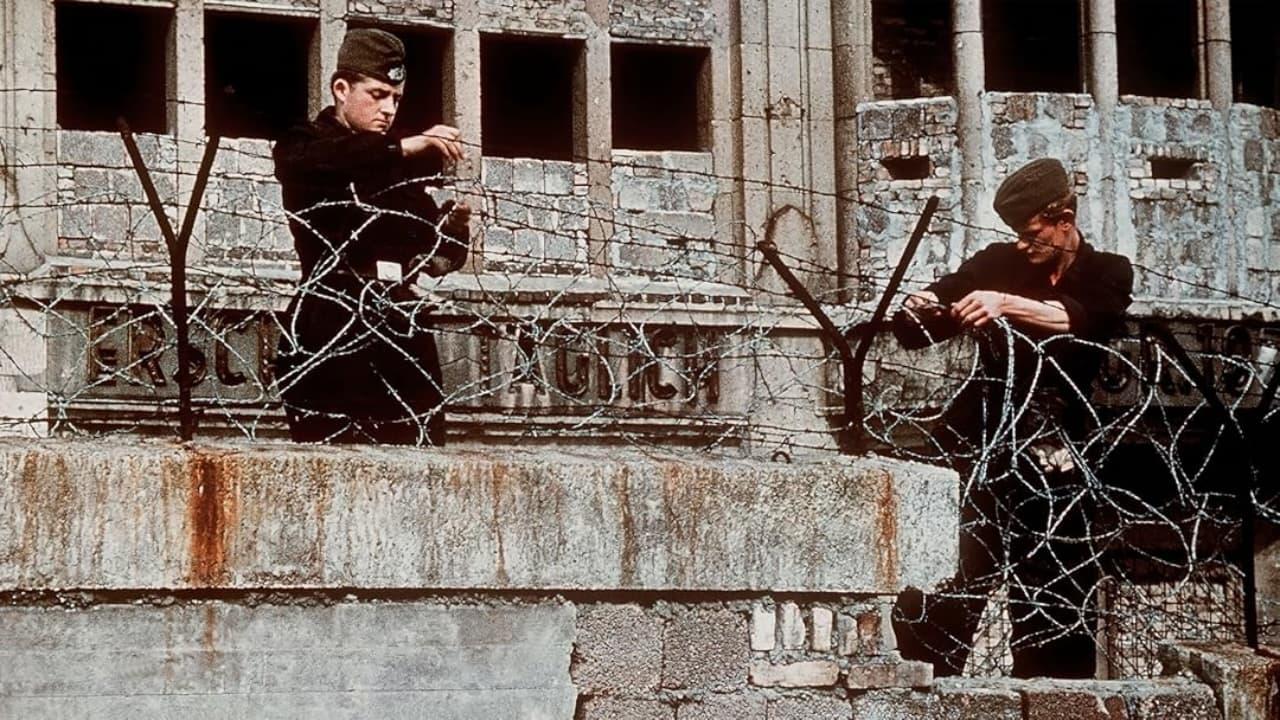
[756,195,938,455]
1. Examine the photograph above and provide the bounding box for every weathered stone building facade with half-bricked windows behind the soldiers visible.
[0,0,1280,446]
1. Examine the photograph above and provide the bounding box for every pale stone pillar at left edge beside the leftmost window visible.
[0,1,58,273]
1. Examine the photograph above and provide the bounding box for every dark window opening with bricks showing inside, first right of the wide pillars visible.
[872,0,954,99]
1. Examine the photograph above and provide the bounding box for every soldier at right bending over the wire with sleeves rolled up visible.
[895,159,1133,676]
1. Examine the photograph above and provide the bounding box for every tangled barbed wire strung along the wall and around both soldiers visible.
[0,116,1280,675]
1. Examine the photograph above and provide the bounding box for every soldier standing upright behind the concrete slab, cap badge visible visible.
[273,29,471,445]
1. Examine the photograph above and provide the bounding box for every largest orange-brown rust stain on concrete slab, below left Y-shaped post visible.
[187,452,239,587]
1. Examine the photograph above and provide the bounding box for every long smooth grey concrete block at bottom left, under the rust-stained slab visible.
[0,602,576,719]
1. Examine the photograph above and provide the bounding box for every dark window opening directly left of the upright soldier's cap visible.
[205,13,315,138]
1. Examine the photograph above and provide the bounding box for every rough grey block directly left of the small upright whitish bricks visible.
[662,607,750,689]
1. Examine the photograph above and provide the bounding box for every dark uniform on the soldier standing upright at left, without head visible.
[273,108,467,442]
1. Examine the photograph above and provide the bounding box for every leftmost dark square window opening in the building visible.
[54,3,173,133]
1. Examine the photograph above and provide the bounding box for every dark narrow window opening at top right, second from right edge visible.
[1116,0,1197,97]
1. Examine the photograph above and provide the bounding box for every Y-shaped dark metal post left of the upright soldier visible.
[116,118,219,441]
